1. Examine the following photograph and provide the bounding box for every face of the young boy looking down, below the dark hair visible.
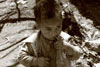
[39,18,62,40]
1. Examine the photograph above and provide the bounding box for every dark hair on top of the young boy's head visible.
[34,0,58,21]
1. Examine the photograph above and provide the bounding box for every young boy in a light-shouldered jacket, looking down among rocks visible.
[18,0,80,67]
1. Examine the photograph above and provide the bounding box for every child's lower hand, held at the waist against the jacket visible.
[37,57,49,67]
